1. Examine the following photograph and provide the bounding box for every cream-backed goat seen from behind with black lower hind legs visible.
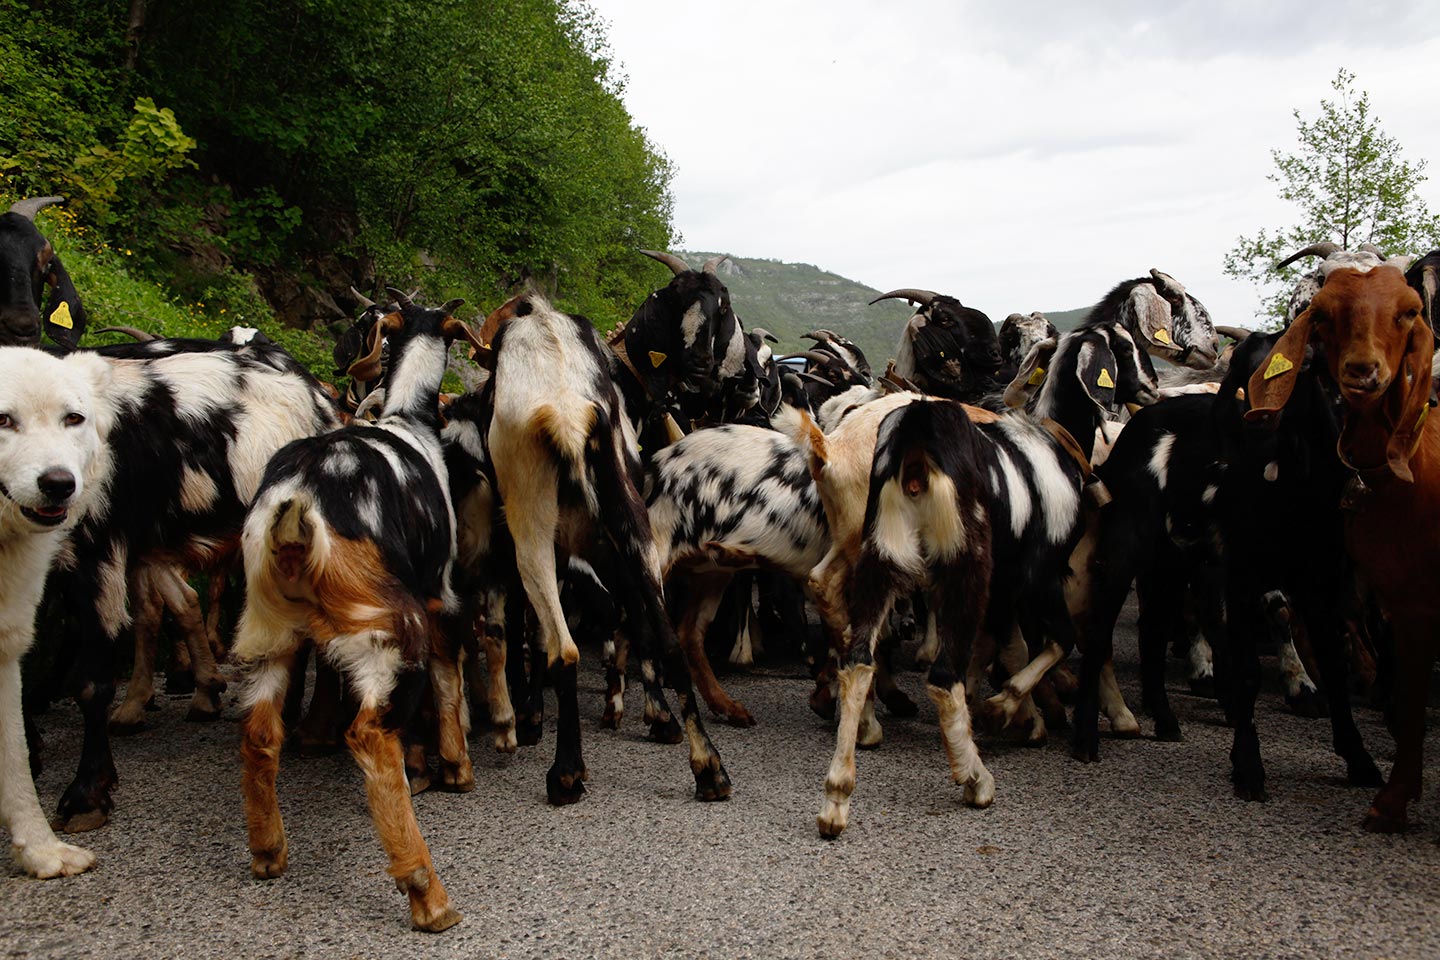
[487,290,730,805]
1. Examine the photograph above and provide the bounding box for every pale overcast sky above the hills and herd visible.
[595,0,1440,324]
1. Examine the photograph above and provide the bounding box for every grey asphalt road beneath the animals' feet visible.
[0,604,1440,960]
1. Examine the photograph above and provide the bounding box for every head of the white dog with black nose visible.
[0,347,109,531]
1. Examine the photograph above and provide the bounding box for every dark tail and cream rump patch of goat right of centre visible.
[865,403,973,571]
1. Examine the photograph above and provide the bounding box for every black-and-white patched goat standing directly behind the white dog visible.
[39,333,340,830]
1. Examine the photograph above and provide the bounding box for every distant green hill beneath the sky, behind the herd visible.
[677,250,1090,368]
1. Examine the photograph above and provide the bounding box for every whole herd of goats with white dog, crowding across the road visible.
[0,197,1440,931]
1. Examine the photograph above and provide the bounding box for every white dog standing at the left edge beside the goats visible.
[0,347,111,877]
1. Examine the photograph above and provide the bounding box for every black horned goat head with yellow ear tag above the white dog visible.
[0,197,85,350]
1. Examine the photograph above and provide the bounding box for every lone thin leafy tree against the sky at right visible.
[1224,69,1440,318]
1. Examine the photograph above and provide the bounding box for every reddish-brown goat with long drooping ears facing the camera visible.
[1246,266,1440,832]
